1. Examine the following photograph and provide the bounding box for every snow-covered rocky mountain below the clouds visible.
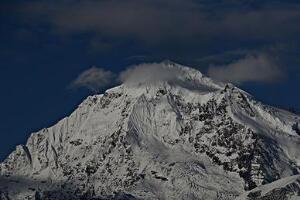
[0,63,300,200]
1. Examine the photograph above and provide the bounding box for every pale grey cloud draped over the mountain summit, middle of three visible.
[119,63,182,84]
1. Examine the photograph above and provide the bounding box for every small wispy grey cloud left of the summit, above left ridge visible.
[71,67,114,92]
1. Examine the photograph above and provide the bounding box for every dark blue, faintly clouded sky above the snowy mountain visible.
[0,0,300,160]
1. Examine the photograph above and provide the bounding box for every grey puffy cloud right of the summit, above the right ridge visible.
[208,54,283,84]
